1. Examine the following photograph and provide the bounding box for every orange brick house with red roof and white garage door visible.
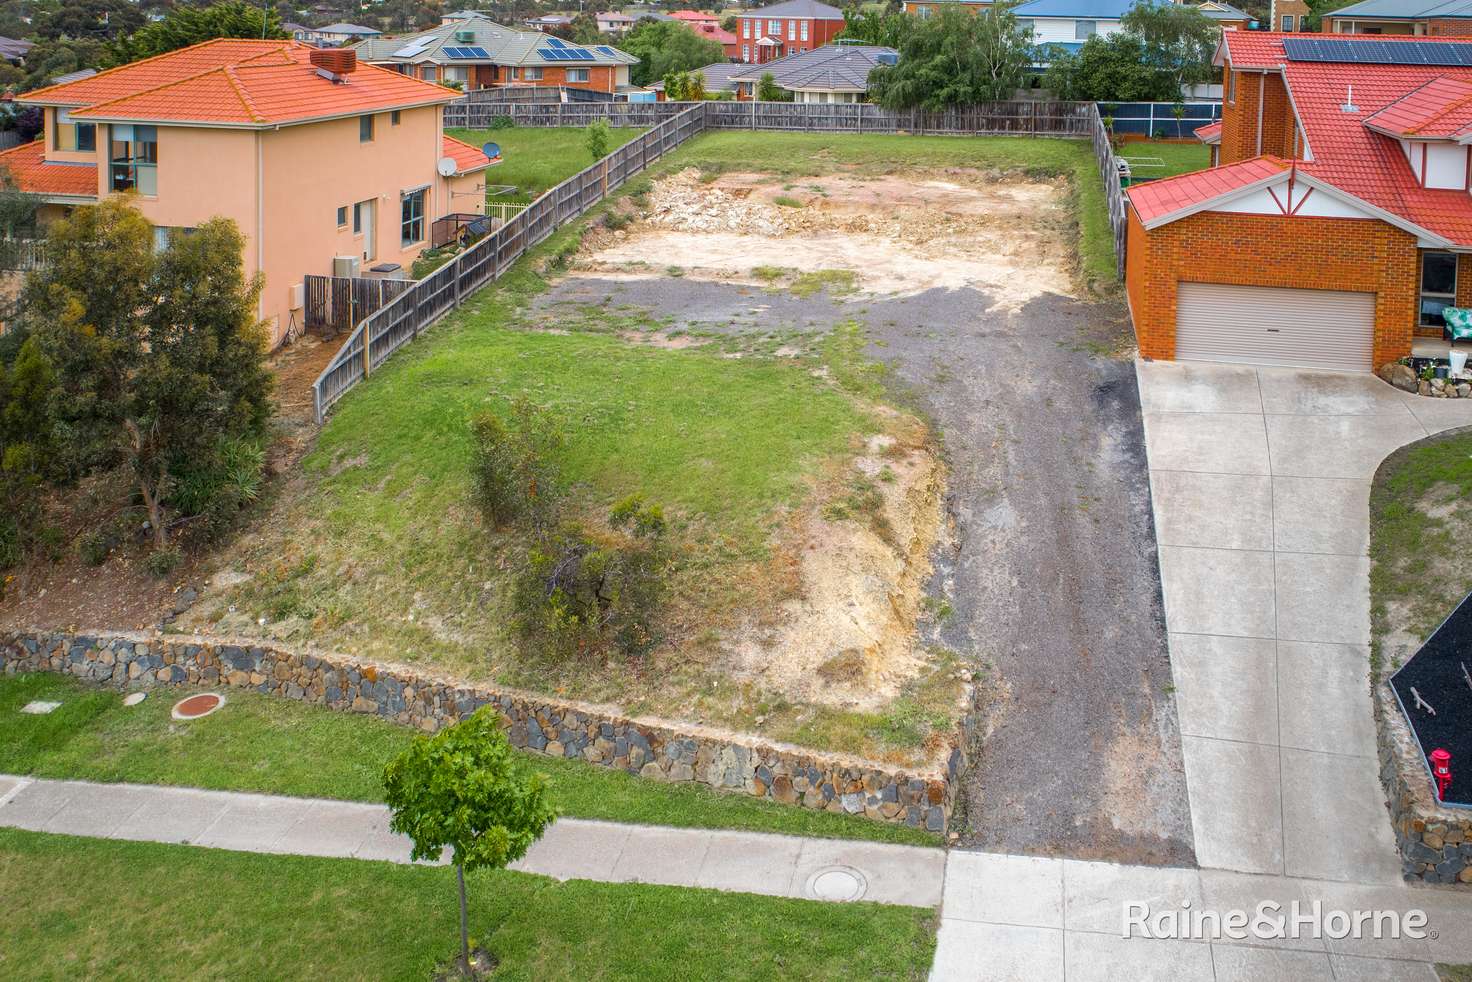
[1125,31,1472,371]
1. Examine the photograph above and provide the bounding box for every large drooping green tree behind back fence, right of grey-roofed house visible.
[868,3,1033,112]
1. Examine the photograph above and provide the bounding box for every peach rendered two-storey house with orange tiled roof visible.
[0,38,493,343]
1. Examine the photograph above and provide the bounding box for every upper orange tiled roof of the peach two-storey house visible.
[19,38,456,127]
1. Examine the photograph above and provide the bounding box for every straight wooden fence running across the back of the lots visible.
[445,99,1098,137]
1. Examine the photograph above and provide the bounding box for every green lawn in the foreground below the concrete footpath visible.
[0,829,935,982]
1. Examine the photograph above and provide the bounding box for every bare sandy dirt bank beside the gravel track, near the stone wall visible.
[732,425,945,710]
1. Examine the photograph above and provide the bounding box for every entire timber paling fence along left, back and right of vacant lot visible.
[312,102,1125,423]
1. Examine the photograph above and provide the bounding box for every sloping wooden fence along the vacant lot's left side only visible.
[312,103,705,423]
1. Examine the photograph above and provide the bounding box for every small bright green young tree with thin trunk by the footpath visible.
[383,707,556,973]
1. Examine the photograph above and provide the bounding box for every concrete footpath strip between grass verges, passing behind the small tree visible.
[0,774,945,907]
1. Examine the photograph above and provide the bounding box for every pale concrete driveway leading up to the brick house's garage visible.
[1138,362,1472,883]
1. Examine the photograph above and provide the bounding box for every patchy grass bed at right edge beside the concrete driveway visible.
[1370,433,1472,671]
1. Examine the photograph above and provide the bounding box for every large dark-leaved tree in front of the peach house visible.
[24,197,271,551]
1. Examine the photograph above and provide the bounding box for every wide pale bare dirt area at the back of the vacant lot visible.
[577,169,1073,308]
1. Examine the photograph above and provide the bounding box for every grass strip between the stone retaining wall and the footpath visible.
[0,673,939,845]
